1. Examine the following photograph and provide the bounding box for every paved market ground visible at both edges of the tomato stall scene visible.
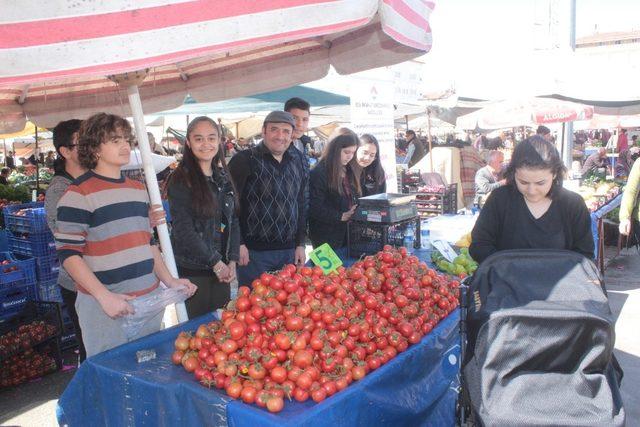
[0,248,640,427]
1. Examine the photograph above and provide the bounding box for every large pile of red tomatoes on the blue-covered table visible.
[172,246,459,412]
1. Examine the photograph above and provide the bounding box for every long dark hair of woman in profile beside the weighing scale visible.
[321,132,361,195]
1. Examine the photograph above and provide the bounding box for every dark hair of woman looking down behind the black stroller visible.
[504,135,567,197]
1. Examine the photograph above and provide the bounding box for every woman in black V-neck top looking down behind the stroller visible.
[469,135,594,263]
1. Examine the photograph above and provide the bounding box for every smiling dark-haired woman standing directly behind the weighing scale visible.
[356,133,387,196]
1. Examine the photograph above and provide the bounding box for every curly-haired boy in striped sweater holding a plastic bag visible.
[55,113,197,357]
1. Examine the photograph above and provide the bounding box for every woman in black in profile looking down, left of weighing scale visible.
[309,132,361,249]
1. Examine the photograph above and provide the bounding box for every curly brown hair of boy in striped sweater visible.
[78,113,133,169]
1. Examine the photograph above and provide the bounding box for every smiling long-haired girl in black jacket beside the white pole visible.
[167,116,240,317]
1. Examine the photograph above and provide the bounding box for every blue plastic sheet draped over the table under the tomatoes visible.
[57,310,460,427]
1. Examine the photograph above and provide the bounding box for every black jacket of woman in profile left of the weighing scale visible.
[309,160,358,248]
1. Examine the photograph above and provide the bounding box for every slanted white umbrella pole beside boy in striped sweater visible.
[127,84,189,326]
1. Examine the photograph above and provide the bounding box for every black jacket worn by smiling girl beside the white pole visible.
[167,169,240,270]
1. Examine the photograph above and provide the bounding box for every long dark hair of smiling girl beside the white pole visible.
[169,116,237,218]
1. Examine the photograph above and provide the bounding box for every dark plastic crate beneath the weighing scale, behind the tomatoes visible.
[347,217,420,258]
